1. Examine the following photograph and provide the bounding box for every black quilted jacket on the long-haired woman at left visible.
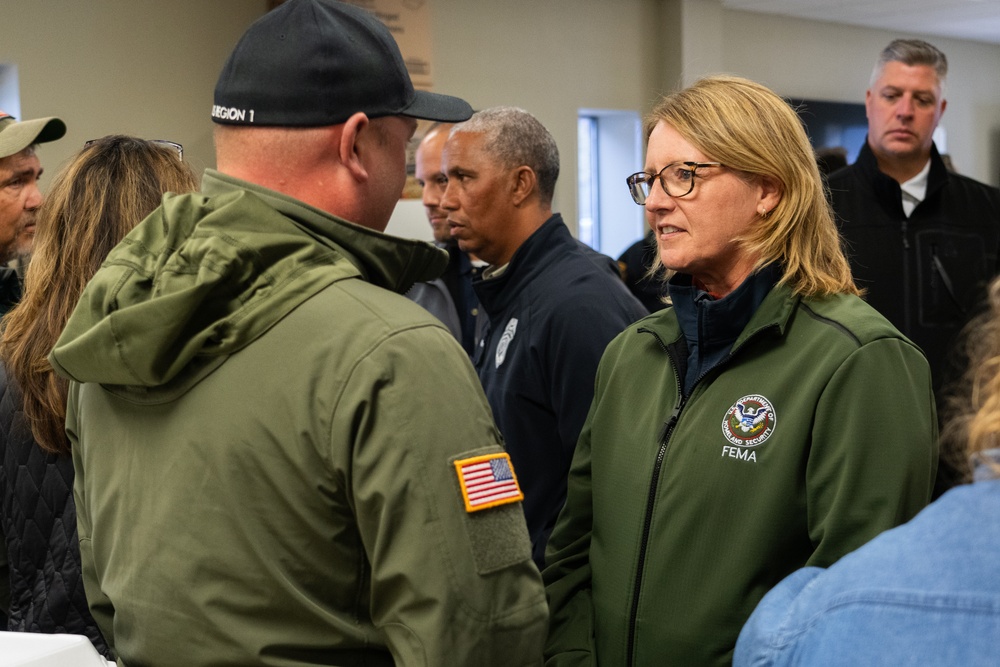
[0,365,110,657]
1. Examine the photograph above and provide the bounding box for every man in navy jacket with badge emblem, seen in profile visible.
[441,107,647,566]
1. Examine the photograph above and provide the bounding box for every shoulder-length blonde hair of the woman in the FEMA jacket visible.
[646,76,861,296]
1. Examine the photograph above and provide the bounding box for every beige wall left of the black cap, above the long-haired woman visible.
[0,0,266,187]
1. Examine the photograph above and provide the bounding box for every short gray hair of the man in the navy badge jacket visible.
[451,107,559,204]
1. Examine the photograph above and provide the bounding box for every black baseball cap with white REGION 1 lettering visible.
[212,0,472,127]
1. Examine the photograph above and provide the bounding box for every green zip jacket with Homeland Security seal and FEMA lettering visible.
[544,285,937,667]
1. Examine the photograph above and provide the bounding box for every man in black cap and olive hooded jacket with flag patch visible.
[51,0,547,666]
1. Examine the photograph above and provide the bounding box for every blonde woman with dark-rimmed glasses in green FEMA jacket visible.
[544,77,937,667]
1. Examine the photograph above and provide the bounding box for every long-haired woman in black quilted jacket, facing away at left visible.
[0,136,198,657]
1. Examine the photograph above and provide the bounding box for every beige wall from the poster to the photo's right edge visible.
[432,0,1000,232]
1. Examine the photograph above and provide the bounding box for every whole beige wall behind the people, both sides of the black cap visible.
[0,0,1000,240]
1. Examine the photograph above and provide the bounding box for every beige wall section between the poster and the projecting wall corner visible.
[431,0,660,237]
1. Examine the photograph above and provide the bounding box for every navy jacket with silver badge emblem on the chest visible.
[473,214,647,567]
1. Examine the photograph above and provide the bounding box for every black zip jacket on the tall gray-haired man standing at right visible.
[829,142,1000,390]
